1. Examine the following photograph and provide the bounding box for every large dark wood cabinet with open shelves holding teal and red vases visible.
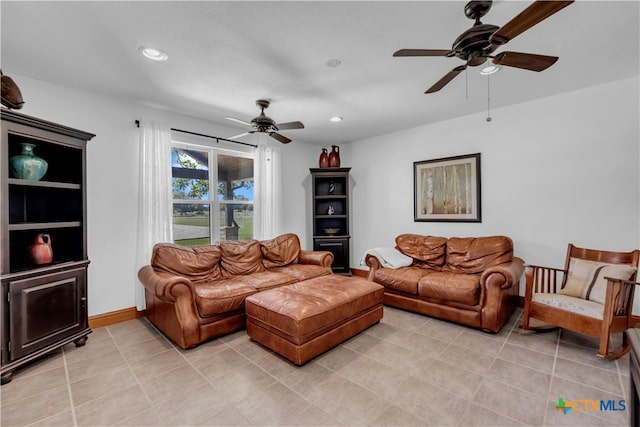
[0,110,95,384]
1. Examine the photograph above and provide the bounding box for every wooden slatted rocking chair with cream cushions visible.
[520,244,640,360]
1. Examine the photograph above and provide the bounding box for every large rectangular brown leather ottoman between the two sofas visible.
[245,275,384,365]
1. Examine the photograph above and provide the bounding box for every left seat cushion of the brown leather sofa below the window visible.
[194,276,258,317]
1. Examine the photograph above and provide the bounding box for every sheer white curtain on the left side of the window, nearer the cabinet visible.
[135,122,173,311]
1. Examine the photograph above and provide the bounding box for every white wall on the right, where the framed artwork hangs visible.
[349,78,640,278]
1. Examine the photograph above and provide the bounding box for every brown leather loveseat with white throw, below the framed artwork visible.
[365,234,524,332]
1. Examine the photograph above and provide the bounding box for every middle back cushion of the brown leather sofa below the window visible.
[220,240,265,277]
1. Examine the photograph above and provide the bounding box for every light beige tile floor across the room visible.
[0,307,629,426]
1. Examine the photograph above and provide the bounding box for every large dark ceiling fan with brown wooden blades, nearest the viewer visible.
[393,0,573,93]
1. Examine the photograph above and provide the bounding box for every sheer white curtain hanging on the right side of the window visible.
[253,142,283,240]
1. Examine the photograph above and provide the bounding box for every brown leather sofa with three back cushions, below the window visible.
[138,233,333,349]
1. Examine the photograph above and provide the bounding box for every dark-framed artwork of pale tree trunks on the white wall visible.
[413,153,482,222]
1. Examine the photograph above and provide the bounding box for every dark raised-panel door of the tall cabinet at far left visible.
[8,268,87,360]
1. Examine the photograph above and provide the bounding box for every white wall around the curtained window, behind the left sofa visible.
[12,75,320,316]
